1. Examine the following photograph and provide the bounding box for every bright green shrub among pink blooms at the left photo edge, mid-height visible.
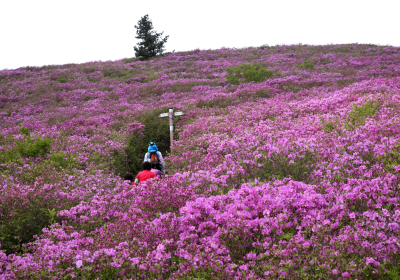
[0,126,54,164]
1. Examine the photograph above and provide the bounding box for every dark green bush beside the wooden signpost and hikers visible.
[113,108,178,177]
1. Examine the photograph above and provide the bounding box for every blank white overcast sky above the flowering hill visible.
[0,0,400,70]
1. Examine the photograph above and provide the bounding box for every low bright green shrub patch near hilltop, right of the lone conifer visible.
[225,63,274,85]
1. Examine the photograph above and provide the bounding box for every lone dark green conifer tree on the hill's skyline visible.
[133,15,169,59]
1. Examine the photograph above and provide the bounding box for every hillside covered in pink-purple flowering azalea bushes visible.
[0,44,400,279]
